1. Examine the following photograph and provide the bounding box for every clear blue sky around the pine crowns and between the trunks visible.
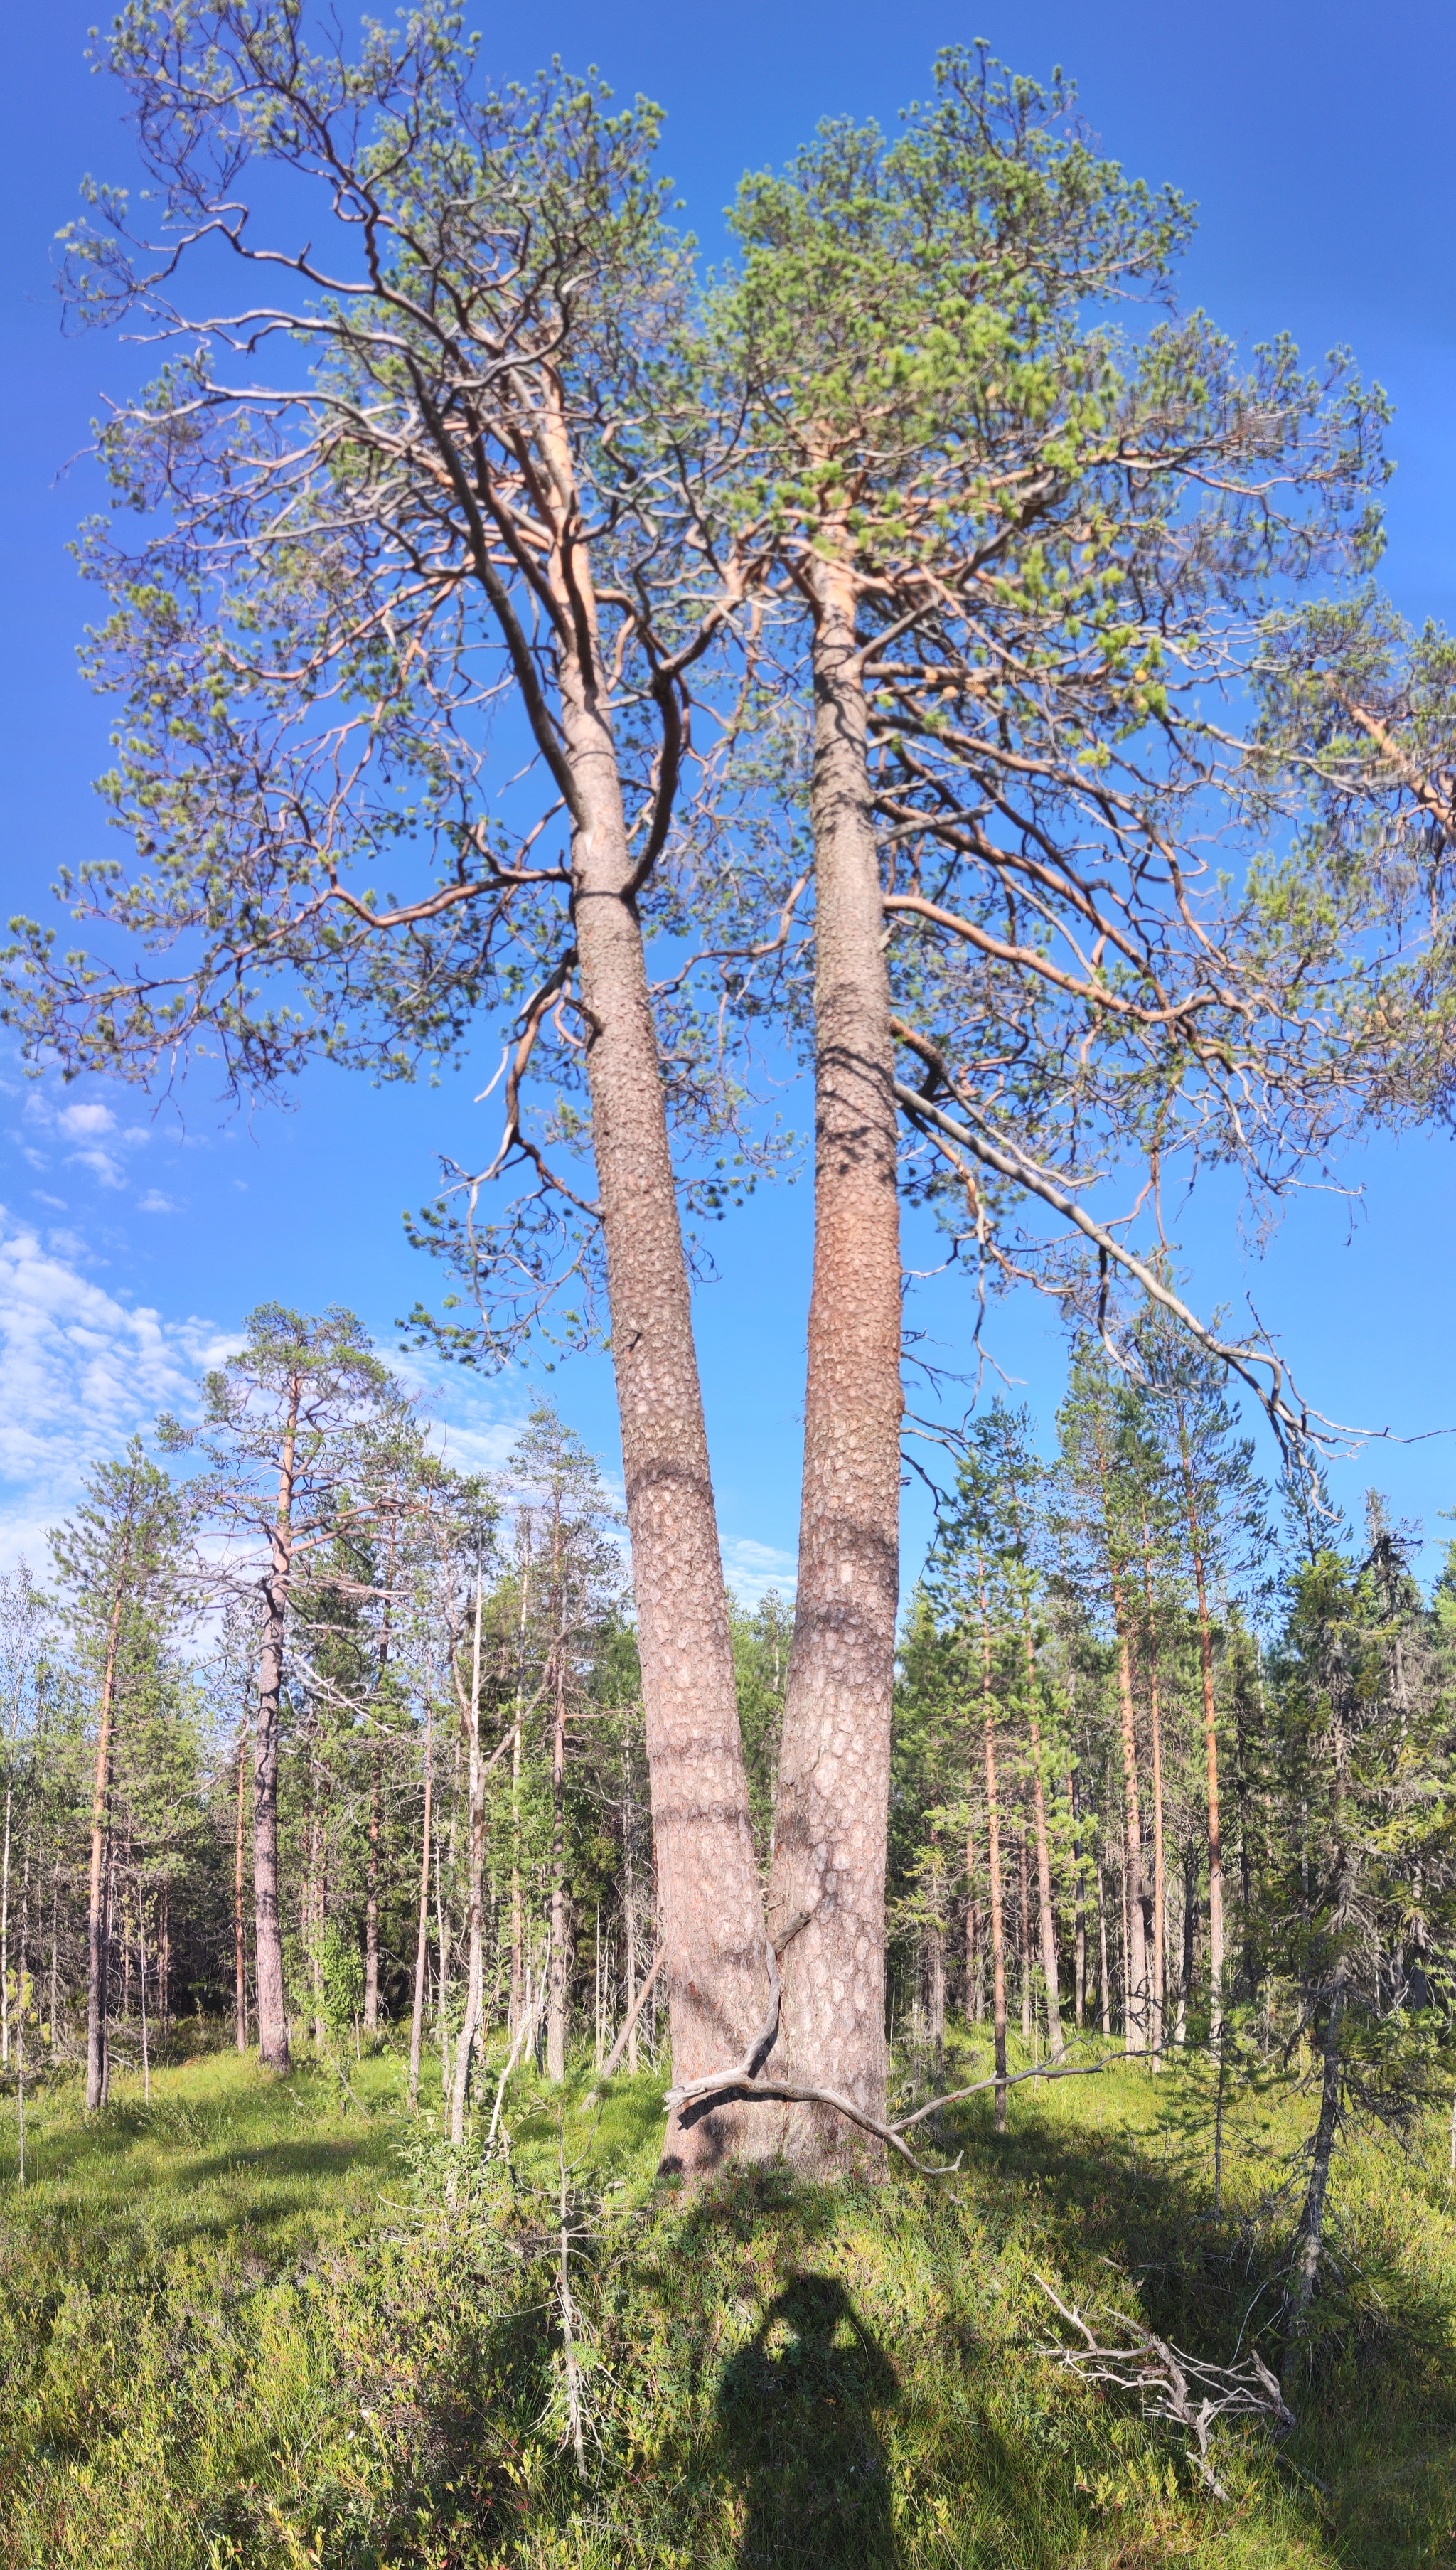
[0,0,1456,1594]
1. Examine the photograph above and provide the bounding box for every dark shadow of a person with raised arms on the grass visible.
[717,2274,899,2570]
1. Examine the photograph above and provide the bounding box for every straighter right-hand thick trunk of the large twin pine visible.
[768,565,901,2169]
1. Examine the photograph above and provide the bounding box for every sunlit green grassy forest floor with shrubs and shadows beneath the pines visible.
[0,2048,1456,2570]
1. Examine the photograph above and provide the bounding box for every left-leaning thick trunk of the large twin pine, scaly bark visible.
[545,501,768,2169]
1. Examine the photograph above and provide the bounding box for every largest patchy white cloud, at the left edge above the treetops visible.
[0,1210,236,1565]
